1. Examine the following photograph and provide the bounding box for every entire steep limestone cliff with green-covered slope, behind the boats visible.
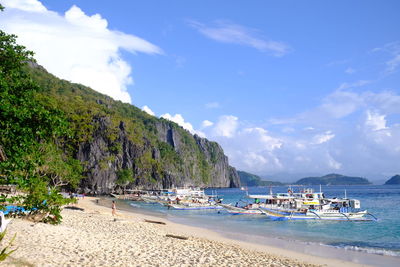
[29,65,240,194]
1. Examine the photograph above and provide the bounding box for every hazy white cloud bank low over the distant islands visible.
[204,90,400,179]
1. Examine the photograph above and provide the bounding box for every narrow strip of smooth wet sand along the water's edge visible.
[109,198,400,266]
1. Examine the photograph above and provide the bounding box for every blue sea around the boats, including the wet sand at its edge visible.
[125,185,400,266]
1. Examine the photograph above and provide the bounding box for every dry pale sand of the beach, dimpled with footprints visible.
[0,197,361,266]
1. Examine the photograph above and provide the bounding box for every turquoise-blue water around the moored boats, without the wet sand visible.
[126,185,400,260]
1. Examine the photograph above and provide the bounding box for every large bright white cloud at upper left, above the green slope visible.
[0,0,162,103]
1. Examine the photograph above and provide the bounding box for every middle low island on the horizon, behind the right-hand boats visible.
[295,173,371,185]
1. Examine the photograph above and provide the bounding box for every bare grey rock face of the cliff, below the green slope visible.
[77,117,240,194]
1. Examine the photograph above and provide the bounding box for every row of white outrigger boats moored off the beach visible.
[114,188,376,221]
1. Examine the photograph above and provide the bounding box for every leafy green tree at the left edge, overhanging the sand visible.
[0,18,82,223]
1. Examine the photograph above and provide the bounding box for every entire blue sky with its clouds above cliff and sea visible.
[0,0,400,180]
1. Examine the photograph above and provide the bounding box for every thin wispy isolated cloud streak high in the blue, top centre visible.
[188,20,290,57]
